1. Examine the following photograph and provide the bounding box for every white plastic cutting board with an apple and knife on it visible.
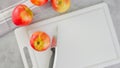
[15,3,120,68]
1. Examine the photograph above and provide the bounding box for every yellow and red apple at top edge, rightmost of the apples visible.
[51,0,71,13]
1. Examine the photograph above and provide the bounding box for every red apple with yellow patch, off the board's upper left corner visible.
[12,4,33,26]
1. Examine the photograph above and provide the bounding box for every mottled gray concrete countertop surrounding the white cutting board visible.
[0,0,120,68]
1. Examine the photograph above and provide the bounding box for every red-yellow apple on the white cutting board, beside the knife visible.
[30,31,50,51]
